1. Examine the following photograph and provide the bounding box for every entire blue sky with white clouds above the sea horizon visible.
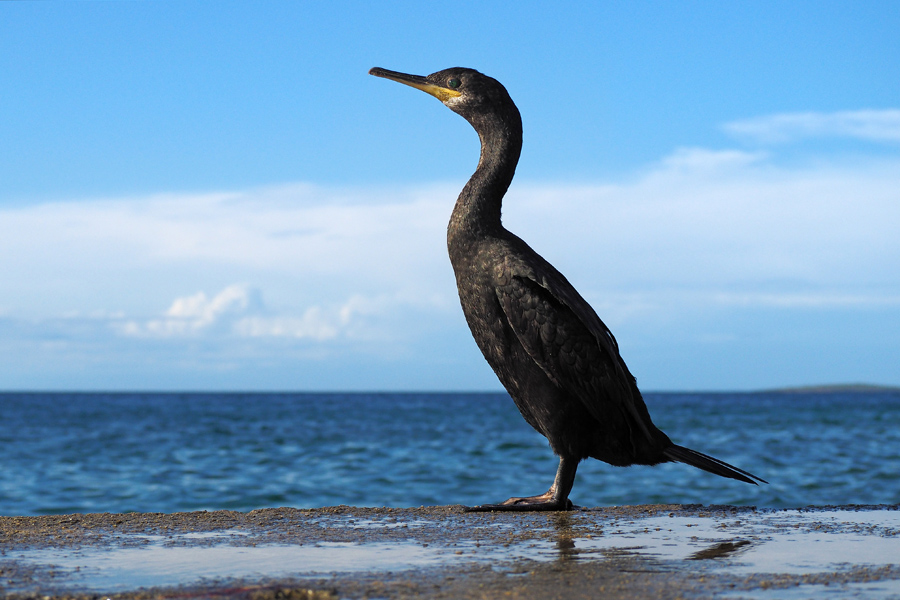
[0,1,900,390]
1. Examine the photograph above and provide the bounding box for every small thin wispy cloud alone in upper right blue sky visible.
[723,109,900,144]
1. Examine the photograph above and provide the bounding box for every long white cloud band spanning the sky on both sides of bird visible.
[0,148,900,328]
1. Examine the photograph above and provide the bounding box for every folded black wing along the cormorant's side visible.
[496,272,653,440]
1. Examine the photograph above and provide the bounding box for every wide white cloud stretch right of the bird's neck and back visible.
[504,151,900,296]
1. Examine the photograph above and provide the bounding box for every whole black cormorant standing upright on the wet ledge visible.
[369,67,765,511]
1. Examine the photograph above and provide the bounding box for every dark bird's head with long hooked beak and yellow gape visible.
[369,67,518,125]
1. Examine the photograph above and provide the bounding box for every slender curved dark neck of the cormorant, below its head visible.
[447,108,522,243]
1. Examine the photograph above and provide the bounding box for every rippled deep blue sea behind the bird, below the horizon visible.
[0,392,900,515]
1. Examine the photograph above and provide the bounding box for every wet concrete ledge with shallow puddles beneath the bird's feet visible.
[0,505,900,600]
